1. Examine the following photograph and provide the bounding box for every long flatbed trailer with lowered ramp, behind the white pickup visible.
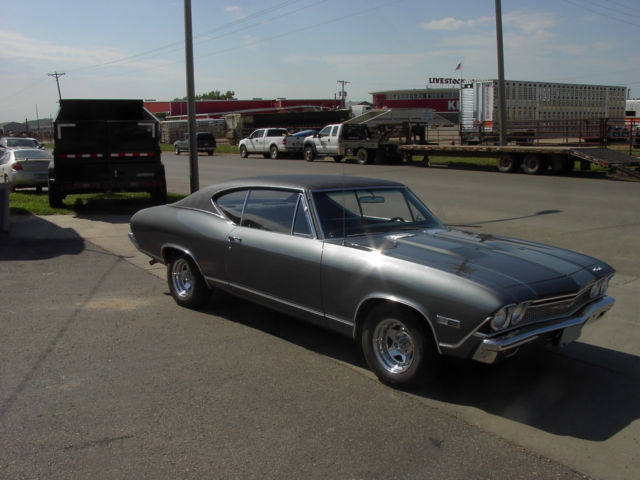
[398,144,640,179]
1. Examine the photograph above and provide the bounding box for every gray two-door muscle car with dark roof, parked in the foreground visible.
[129,175,614,387]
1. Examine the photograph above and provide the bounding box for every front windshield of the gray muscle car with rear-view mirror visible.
[313,188,442,238]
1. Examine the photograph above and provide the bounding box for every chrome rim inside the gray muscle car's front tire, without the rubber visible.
[372,319,414,374]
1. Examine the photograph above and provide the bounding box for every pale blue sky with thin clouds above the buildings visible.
[0,0,640,122]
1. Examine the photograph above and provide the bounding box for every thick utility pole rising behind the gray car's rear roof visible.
[184,0,200,193]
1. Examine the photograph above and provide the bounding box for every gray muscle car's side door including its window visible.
[226,189,324,324]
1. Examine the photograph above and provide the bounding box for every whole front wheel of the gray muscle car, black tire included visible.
[360,304,439,388]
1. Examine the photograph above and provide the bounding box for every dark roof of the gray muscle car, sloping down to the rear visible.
[175,175,405,208]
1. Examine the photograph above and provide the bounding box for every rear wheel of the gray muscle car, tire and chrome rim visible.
[167,253,211,308]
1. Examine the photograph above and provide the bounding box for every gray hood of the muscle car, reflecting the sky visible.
[342,229,613,298]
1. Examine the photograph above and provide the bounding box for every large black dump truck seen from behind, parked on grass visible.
[48,100,167,208]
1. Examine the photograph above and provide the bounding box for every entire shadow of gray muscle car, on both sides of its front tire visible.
[200,295,640,441]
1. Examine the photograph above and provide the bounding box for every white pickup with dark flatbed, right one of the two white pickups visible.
[304,123,378,164]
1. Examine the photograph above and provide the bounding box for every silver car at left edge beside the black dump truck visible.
[0,148,53,193]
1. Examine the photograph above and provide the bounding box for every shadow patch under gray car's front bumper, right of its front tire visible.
[413,342,640,442]
